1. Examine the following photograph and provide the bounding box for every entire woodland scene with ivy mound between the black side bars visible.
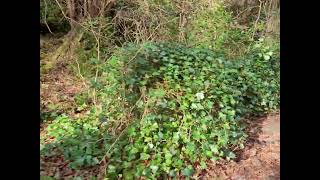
[40,0,280,179]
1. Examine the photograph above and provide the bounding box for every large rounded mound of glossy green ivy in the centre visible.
[40,43,280,179]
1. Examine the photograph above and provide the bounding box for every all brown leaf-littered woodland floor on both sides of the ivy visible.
[40,35,280,180]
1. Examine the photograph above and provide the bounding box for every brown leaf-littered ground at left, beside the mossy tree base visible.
[40,34,85,119]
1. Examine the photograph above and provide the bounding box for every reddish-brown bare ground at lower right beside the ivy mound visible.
[201,114,280,180]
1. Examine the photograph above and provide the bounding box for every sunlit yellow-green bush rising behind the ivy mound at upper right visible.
[187,3,253,57]
